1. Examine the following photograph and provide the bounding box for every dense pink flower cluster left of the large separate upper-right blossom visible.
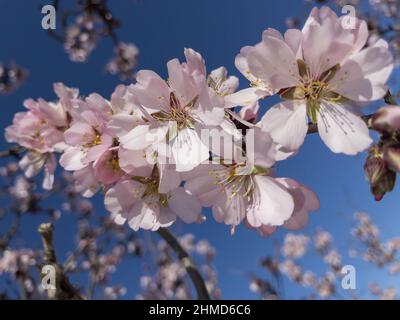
[6,42,319,235]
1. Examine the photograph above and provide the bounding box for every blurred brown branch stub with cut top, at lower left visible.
[38,223,83,300]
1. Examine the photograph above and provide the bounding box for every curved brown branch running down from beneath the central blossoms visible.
[157,228,211,300]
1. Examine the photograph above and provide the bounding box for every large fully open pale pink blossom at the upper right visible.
[236,7,393,155]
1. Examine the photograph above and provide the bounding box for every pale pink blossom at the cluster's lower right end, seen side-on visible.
[185,128,319,235]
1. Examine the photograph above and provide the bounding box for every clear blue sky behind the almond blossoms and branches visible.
[0,0,400,299]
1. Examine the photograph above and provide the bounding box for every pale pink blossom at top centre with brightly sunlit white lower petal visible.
[121,49,231,172]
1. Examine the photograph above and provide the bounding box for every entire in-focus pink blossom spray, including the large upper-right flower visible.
[6,7,393,235]
